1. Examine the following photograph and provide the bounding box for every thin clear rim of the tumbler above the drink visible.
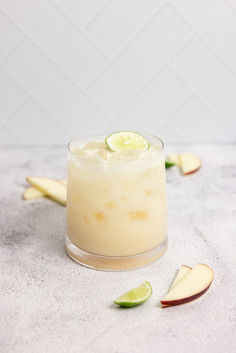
[67,130,165,155]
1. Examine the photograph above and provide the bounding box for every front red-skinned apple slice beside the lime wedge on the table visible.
[161,264,214,306]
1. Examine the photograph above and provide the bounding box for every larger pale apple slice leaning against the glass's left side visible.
[26,176,66,206]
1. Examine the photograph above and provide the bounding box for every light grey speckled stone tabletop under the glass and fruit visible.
[0,145,236,353]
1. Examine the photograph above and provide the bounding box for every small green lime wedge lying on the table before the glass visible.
[114,281,152,307]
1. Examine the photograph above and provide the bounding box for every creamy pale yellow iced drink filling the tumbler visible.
[67,135,166,256]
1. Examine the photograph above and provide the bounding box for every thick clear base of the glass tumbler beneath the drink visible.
[66,237,168,271]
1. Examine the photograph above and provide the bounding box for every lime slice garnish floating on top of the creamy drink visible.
[105,131,150,152]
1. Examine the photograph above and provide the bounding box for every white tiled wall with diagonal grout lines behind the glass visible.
[0,0,236,145]
